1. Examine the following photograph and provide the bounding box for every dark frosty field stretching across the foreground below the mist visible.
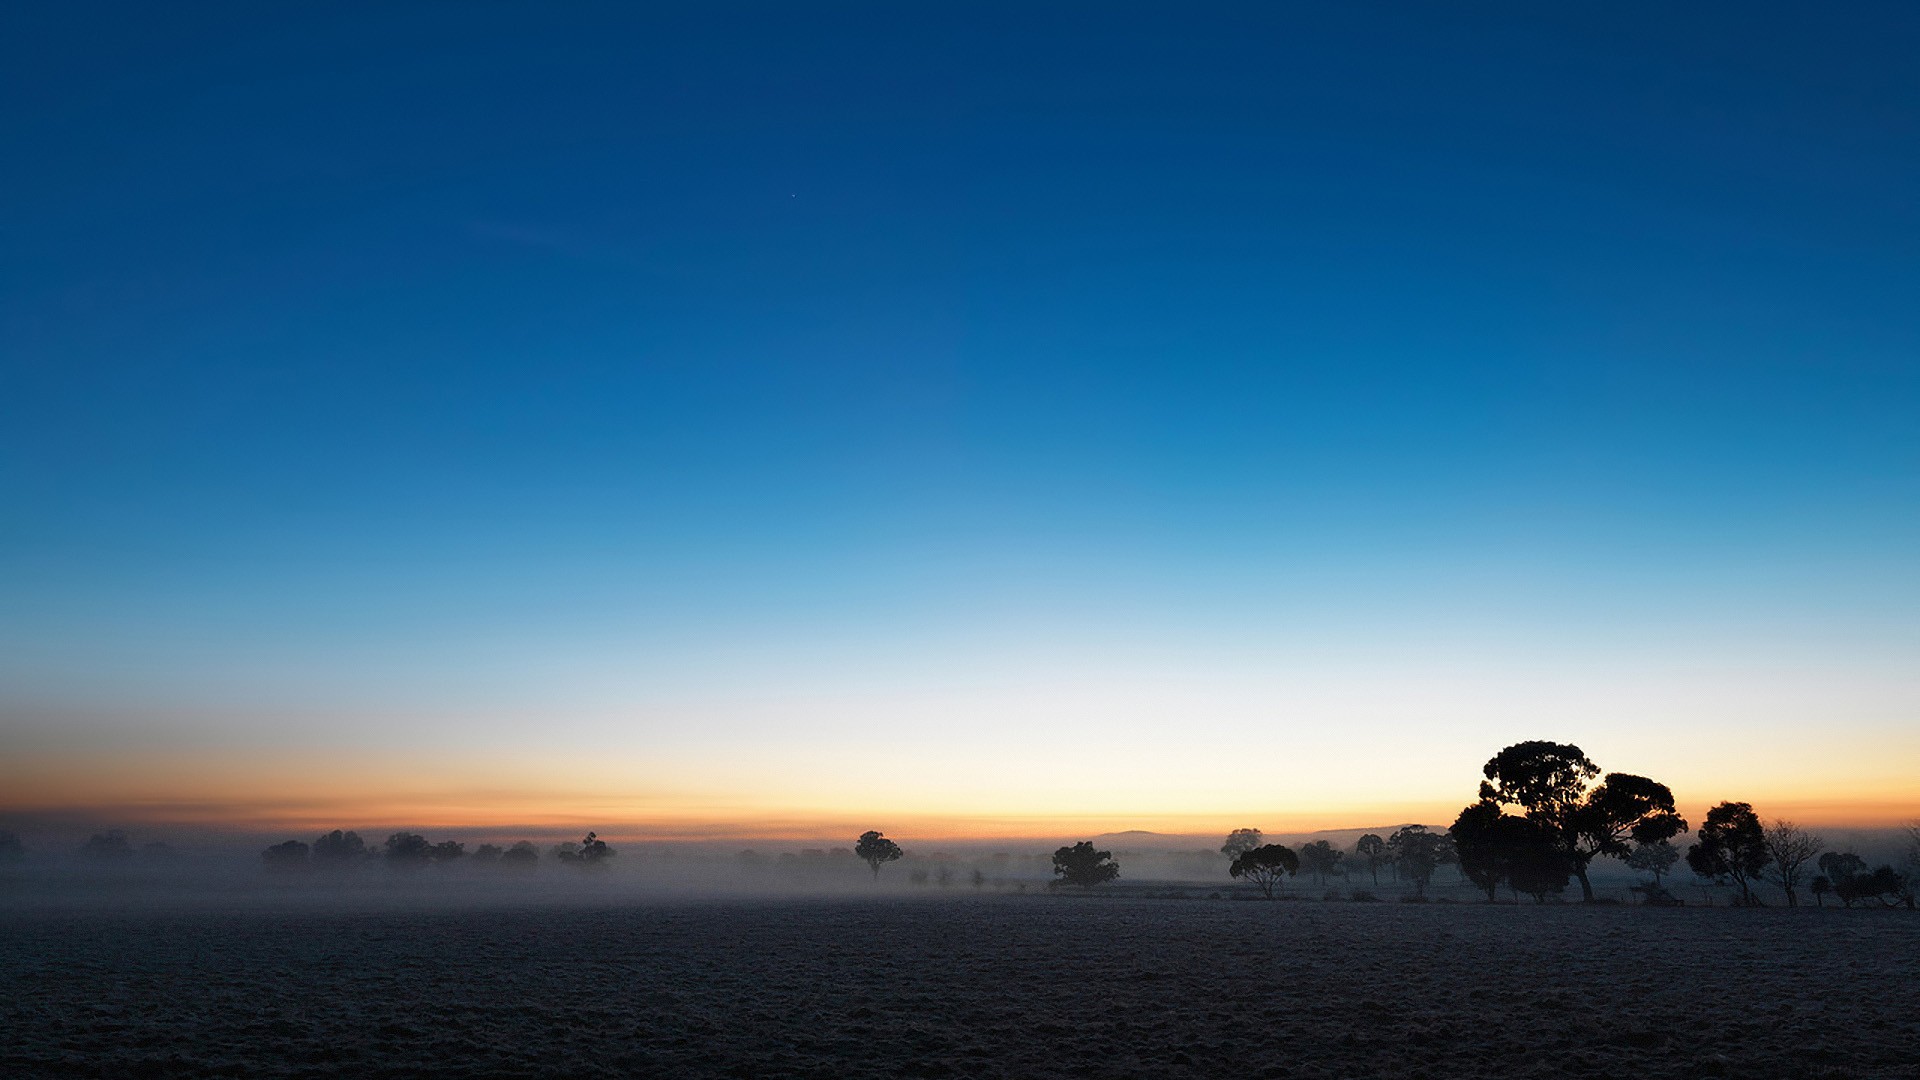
[0,897,1920,1078]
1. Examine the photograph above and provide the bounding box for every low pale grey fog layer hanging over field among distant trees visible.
[0,826,1920,907]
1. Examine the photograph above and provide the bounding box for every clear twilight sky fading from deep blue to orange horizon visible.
[0,2,1920,836]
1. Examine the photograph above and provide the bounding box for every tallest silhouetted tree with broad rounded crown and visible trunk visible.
[1480,740,1686,901]
